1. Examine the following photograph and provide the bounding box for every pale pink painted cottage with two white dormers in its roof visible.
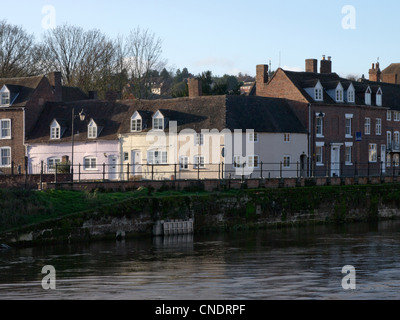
[26,100,126,181]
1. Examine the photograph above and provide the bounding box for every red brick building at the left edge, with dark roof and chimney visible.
[0,72,85,174]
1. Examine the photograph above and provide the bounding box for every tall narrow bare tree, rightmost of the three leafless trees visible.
[123,27,165,98]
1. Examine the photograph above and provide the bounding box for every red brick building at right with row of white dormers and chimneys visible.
[256,56,400,176]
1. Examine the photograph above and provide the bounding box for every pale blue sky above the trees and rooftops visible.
[0,0,400,76]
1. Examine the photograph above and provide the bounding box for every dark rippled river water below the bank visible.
[0,221,400,300]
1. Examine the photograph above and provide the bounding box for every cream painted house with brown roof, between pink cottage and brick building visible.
[118,96,308,180]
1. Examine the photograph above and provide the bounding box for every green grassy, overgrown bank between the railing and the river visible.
[0,184,400,233]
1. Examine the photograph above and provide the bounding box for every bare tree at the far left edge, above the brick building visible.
[0,20,40,78]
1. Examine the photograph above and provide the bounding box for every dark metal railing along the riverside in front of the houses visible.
[24,161,400,182]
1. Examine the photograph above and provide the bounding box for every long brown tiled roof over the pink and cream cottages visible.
[27,95,306,143]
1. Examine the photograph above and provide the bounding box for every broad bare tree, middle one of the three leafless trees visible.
[42,24,115,95]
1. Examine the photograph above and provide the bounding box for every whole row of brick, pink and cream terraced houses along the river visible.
[0,57,400,181]
